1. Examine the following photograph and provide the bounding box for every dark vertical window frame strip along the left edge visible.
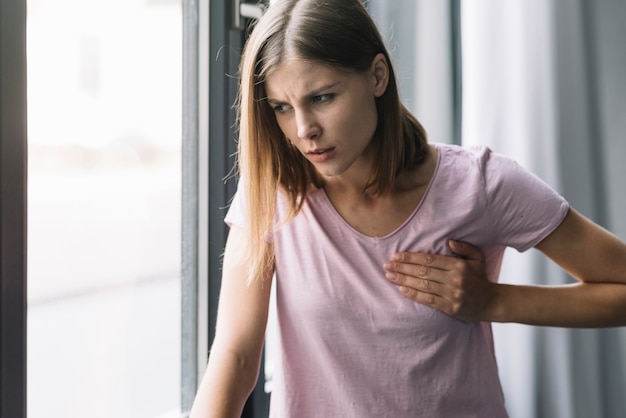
[0,0,27,418]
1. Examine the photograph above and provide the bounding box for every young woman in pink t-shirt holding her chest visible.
[191,0,626,418]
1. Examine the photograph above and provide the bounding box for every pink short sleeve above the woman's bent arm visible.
[481,148,569,252]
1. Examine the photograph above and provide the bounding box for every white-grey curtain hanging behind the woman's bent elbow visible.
[461,0,626,418]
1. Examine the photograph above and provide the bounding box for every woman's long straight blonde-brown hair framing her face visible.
[237,0,427,283]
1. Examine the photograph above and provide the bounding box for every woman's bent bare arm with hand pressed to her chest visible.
[385,209,626,328]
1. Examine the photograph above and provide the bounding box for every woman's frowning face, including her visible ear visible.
[265,54,388,177]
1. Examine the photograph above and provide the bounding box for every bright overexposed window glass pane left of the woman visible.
[27,0,182,418]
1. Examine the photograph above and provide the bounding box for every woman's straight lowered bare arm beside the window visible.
[190,226,273,418]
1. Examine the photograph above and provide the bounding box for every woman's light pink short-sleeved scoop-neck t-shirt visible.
[226,145,569,418]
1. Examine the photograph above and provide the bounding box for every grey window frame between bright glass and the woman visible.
[181,0,269,417]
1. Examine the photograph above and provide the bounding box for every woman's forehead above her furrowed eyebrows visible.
[265,59,357,98]
